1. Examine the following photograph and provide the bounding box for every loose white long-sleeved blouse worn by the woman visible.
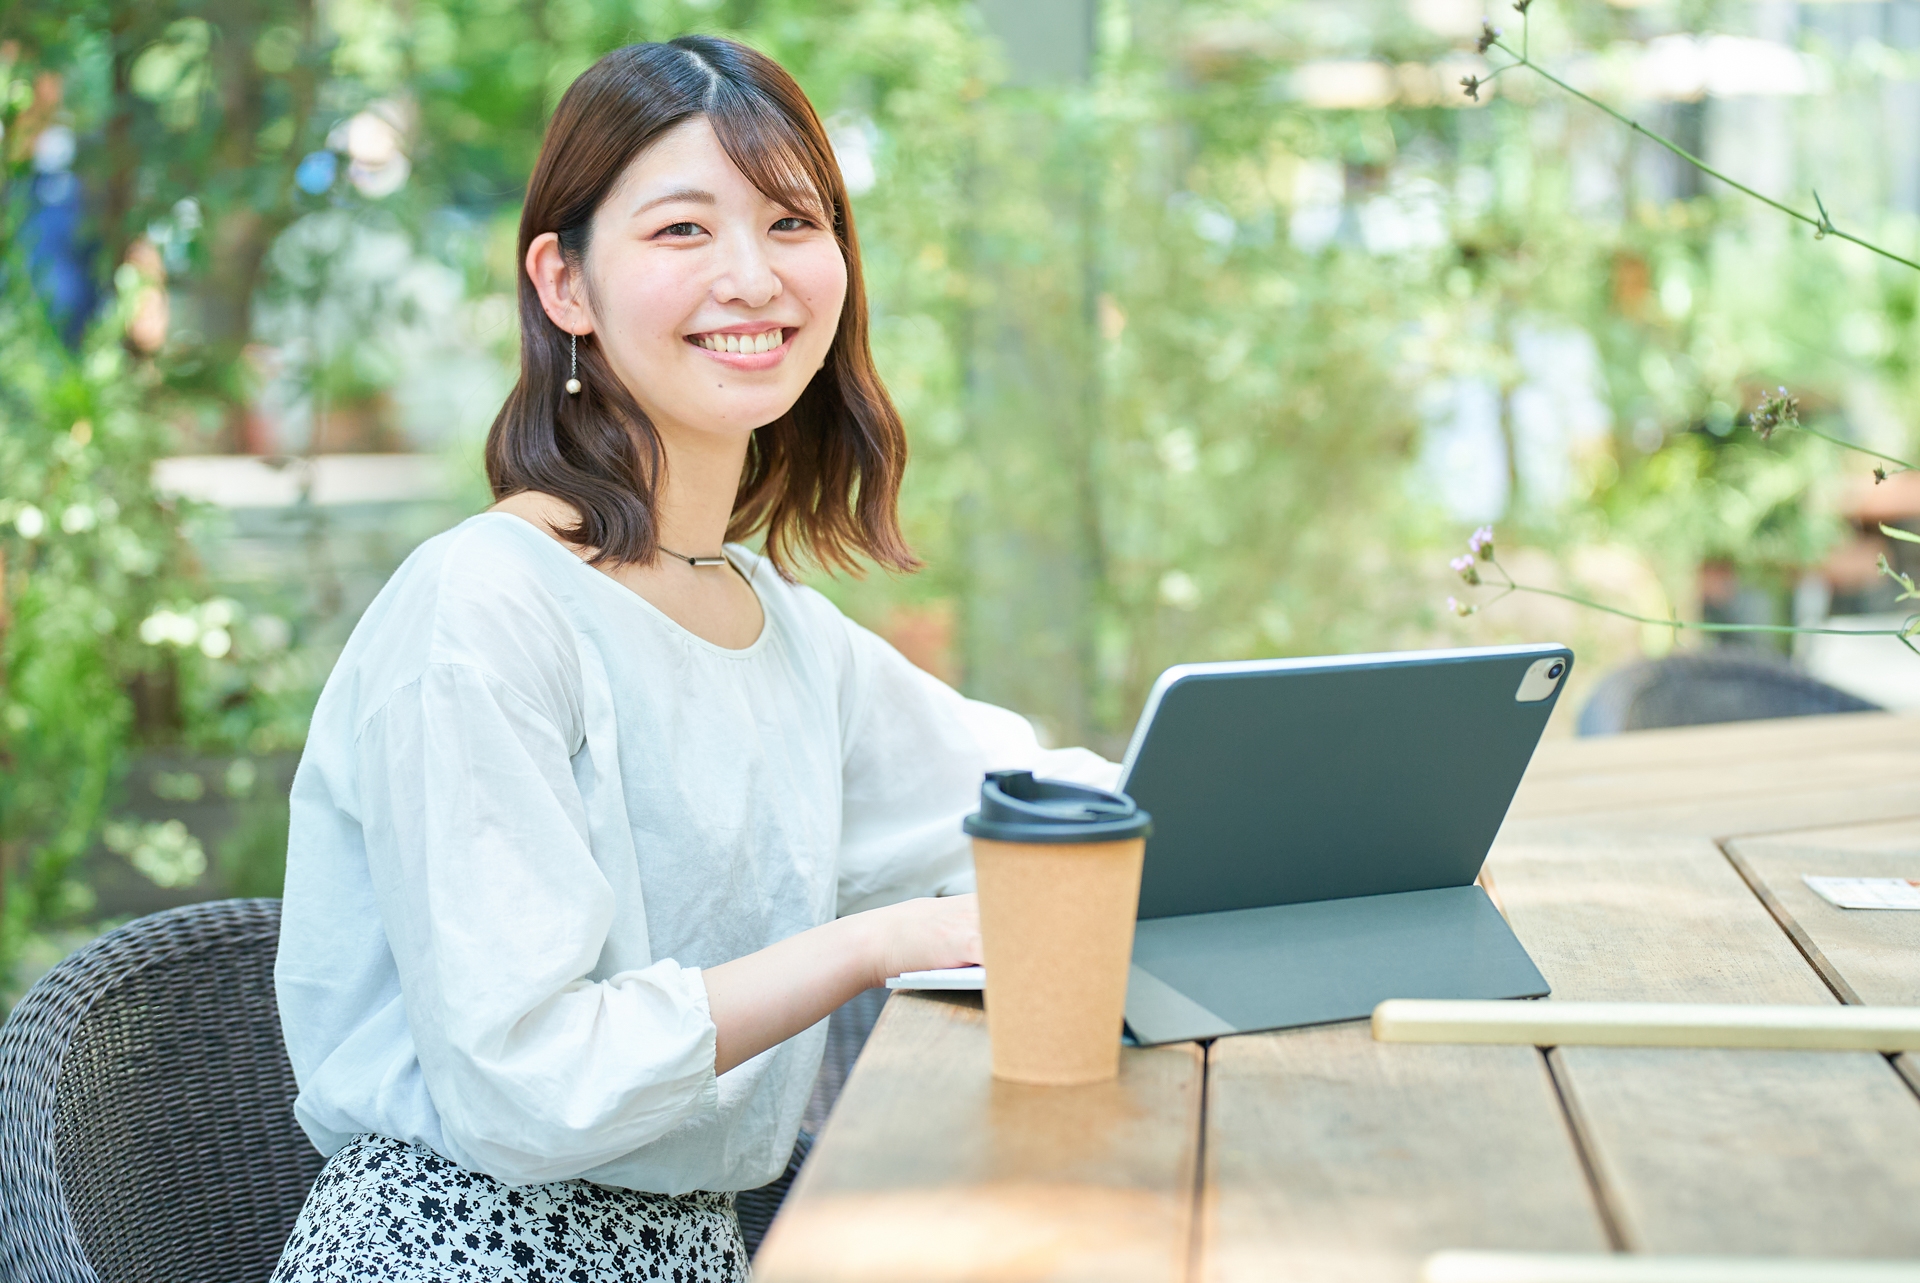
[275,513,1117,1193]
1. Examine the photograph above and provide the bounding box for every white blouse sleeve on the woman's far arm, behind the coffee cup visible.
[839,617,1119,914]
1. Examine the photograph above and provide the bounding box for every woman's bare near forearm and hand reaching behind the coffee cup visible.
[701,895,979,1074]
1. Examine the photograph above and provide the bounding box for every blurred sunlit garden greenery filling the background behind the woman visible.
[0,0,1920,1001]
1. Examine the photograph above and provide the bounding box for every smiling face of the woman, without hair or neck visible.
[549,117,847,445]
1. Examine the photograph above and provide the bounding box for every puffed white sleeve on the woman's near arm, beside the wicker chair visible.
[357,663,718,1185]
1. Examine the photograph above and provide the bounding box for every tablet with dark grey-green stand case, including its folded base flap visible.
[1123,645,1572,1045]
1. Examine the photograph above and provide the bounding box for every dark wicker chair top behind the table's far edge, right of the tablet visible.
[1576,653,1880,736]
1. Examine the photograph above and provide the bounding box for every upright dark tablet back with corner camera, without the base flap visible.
[1121,645,1572,918]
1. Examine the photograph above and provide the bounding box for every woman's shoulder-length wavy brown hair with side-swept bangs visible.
[486,36,920,578]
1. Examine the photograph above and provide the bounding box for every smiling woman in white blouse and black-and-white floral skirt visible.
[275,36,1112,1283]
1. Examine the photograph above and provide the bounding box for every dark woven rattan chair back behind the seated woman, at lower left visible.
[0,901,323,1283]
